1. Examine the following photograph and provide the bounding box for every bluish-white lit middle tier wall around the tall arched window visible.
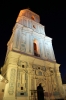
[8,24,55,61]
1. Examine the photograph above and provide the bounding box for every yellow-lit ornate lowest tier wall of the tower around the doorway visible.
[2,51,63,100]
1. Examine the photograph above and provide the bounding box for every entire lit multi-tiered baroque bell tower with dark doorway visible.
[1,9,64,100]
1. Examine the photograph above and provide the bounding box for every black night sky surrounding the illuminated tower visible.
[0,0,66,82]
